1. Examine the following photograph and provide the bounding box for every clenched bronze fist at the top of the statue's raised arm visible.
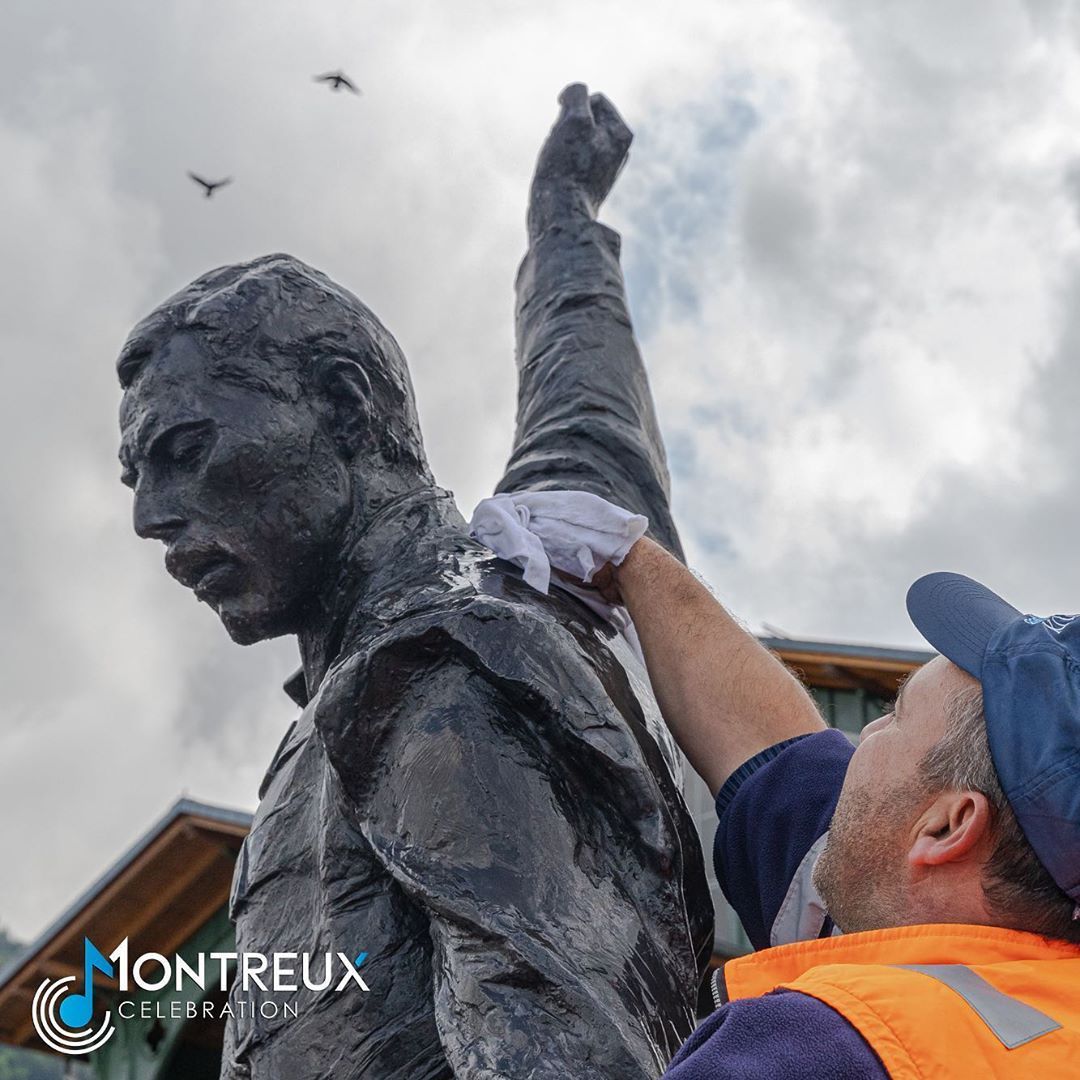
[528,82,633,240]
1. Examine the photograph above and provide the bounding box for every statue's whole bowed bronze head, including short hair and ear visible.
[117,255,431,644]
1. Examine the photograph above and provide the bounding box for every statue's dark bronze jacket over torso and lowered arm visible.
[222,511,712,1080]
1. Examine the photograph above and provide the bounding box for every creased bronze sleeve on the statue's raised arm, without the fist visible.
[496,216,683,558]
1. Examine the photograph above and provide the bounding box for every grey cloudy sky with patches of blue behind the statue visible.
[0,0,1080,937]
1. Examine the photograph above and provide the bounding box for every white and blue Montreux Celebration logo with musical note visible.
[30,937,369,1055]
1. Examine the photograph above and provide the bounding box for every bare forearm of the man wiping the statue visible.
[600,537,826,795]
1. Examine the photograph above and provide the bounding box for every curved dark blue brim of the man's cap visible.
[907,573,1021,679]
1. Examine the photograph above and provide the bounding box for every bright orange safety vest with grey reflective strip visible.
[718,923,1080,1080]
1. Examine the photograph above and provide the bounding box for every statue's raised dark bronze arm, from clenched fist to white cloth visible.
[496,84,681,557]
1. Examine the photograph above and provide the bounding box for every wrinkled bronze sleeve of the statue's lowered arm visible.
[319,643,678,1080]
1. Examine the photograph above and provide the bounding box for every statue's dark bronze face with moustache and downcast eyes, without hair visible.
[120,334,352,645]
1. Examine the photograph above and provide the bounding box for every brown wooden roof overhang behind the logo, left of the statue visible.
[0,799,251,1051]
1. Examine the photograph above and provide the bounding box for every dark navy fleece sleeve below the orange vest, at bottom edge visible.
[664,990,889,1080]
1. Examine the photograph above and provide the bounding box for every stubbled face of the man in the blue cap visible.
[814,657,975,933]
